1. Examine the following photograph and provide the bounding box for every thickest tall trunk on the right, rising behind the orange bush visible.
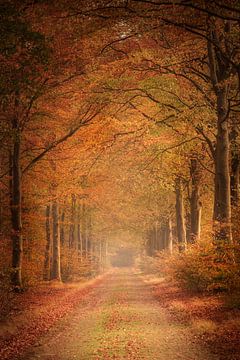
[207,21,232,242]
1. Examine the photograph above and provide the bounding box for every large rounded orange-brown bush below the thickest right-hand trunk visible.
[172,243,240,291]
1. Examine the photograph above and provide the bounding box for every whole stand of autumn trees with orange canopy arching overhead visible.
[0,0,240,289]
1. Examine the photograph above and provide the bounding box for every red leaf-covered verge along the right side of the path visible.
[146,277,240,360]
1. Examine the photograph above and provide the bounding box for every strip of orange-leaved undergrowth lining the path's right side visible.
[139,242,240,298]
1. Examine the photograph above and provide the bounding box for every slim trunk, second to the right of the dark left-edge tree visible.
[51,201,61,281]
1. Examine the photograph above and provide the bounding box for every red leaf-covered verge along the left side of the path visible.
[0,277,106,360]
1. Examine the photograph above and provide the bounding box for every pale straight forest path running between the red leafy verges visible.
[23,269,218,360]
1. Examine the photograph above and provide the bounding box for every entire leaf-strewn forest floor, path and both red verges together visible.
[0,269,240,360]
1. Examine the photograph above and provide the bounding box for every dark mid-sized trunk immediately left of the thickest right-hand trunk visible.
[190,159,202,244]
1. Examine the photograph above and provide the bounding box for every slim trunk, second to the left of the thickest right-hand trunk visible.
[175,178,186,252]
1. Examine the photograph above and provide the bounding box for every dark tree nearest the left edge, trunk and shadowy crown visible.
[0,2,52,290]
